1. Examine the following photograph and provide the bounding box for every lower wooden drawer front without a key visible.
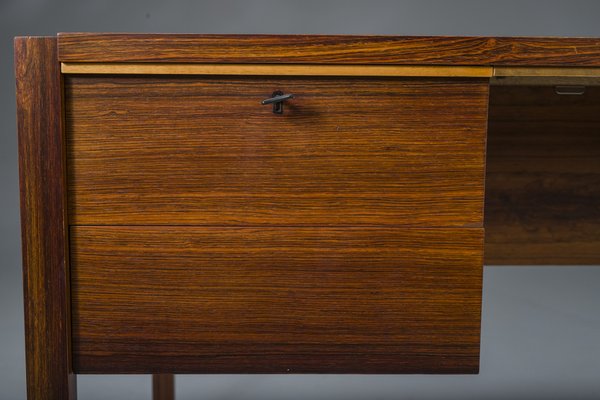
[71,226,483,373]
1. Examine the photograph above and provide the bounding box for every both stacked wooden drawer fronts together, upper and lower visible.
[65,75,488,373]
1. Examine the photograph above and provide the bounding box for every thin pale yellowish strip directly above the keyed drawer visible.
[61,63,492,78]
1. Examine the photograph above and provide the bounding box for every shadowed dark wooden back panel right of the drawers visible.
[485,86,600,265]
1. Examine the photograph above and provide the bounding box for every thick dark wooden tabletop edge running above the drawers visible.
[58,33,600,66]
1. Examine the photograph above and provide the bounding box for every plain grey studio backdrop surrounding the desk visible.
[0,0,600,400]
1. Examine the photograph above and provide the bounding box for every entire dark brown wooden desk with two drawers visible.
[15,34,600,399]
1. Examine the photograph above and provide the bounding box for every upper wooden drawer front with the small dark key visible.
[65,76,488,226]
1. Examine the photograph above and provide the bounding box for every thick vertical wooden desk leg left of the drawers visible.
[14,37,76,400]
